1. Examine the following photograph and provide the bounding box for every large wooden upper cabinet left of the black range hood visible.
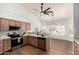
[0,18,9,31]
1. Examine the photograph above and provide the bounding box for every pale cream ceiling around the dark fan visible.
[21,3,73,22]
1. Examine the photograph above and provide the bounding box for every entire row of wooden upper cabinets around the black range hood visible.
[0,18,31,32]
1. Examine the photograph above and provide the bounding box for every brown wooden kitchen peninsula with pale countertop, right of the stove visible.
[23,34,50,51]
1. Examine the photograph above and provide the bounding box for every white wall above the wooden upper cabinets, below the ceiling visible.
[0,3,41,30]
